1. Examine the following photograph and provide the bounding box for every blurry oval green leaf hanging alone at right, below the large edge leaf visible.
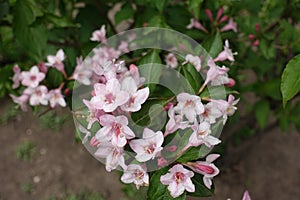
[255,100,270,129]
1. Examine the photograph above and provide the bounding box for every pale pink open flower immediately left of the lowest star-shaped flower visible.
[121,164,149,189]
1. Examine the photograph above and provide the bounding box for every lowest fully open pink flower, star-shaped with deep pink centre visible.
[160,164,195,198]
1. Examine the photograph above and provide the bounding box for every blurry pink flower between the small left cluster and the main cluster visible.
[73,57,93,85]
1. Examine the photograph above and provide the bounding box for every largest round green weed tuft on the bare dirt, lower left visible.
[15,141,36,161]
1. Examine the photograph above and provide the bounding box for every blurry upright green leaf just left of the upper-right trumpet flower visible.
[203,32,223,58]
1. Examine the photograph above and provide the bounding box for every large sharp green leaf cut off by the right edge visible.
[281,54,300,106]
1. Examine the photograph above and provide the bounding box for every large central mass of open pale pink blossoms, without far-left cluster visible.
[74,24,238,198]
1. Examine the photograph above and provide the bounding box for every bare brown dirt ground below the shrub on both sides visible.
[0,97,300,200]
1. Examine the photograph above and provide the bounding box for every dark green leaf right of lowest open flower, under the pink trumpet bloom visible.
[188,173,215,197]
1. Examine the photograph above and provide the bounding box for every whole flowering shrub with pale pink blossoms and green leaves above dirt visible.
[0,0,300,199]
